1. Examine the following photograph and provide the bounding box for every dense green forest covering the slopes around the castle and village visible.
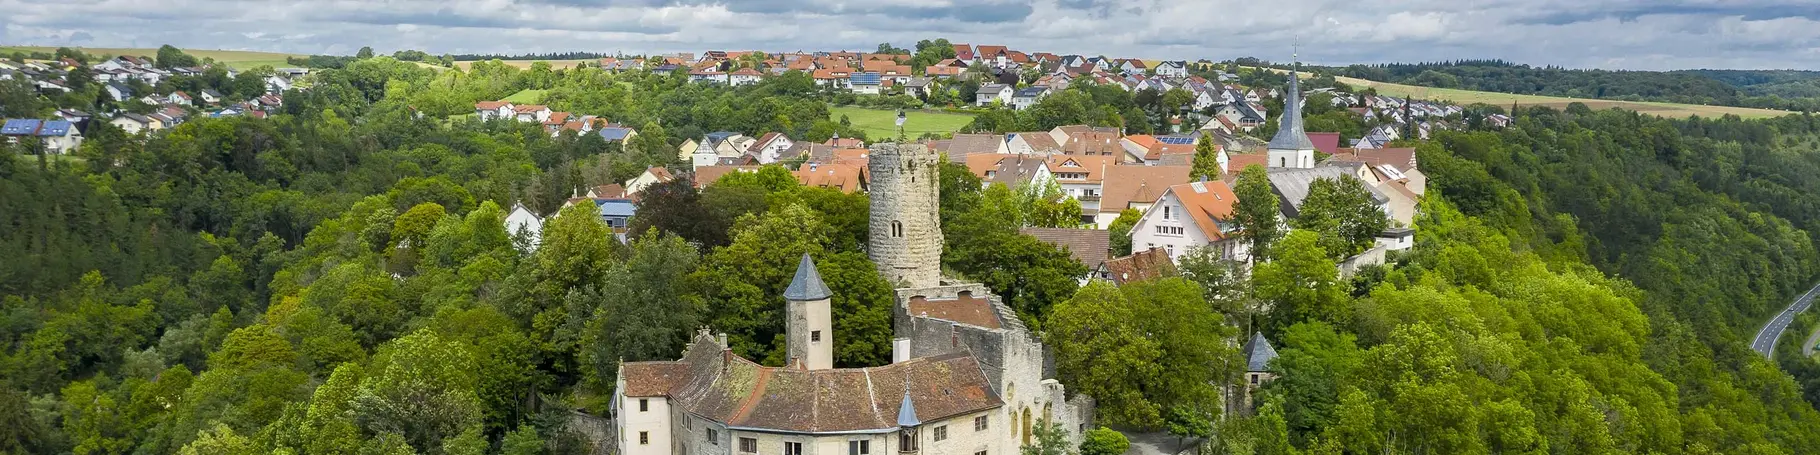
[10,48,1820,455]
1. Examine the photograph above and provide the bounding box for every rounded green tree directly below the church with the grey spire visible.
[1290,177,1390,258]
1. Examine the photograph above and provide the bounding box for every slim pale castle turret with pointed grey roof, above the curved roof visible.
[784,253,834,369]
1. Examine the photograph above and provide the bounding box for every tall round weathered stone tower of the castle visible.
[866,144,943,288]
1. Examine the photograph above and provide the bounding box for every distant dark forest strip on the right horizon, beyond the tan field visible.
[1327,60,1820,111]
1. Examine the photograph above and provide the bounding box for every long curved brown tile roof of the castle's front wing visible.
[637,333,1005,433]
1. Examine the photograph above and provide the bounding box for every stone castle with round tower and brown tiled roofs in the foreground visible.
[612,144,1094,455]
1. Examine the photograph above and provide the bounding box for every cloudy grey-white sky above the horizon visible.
[0,0,1820,69]
